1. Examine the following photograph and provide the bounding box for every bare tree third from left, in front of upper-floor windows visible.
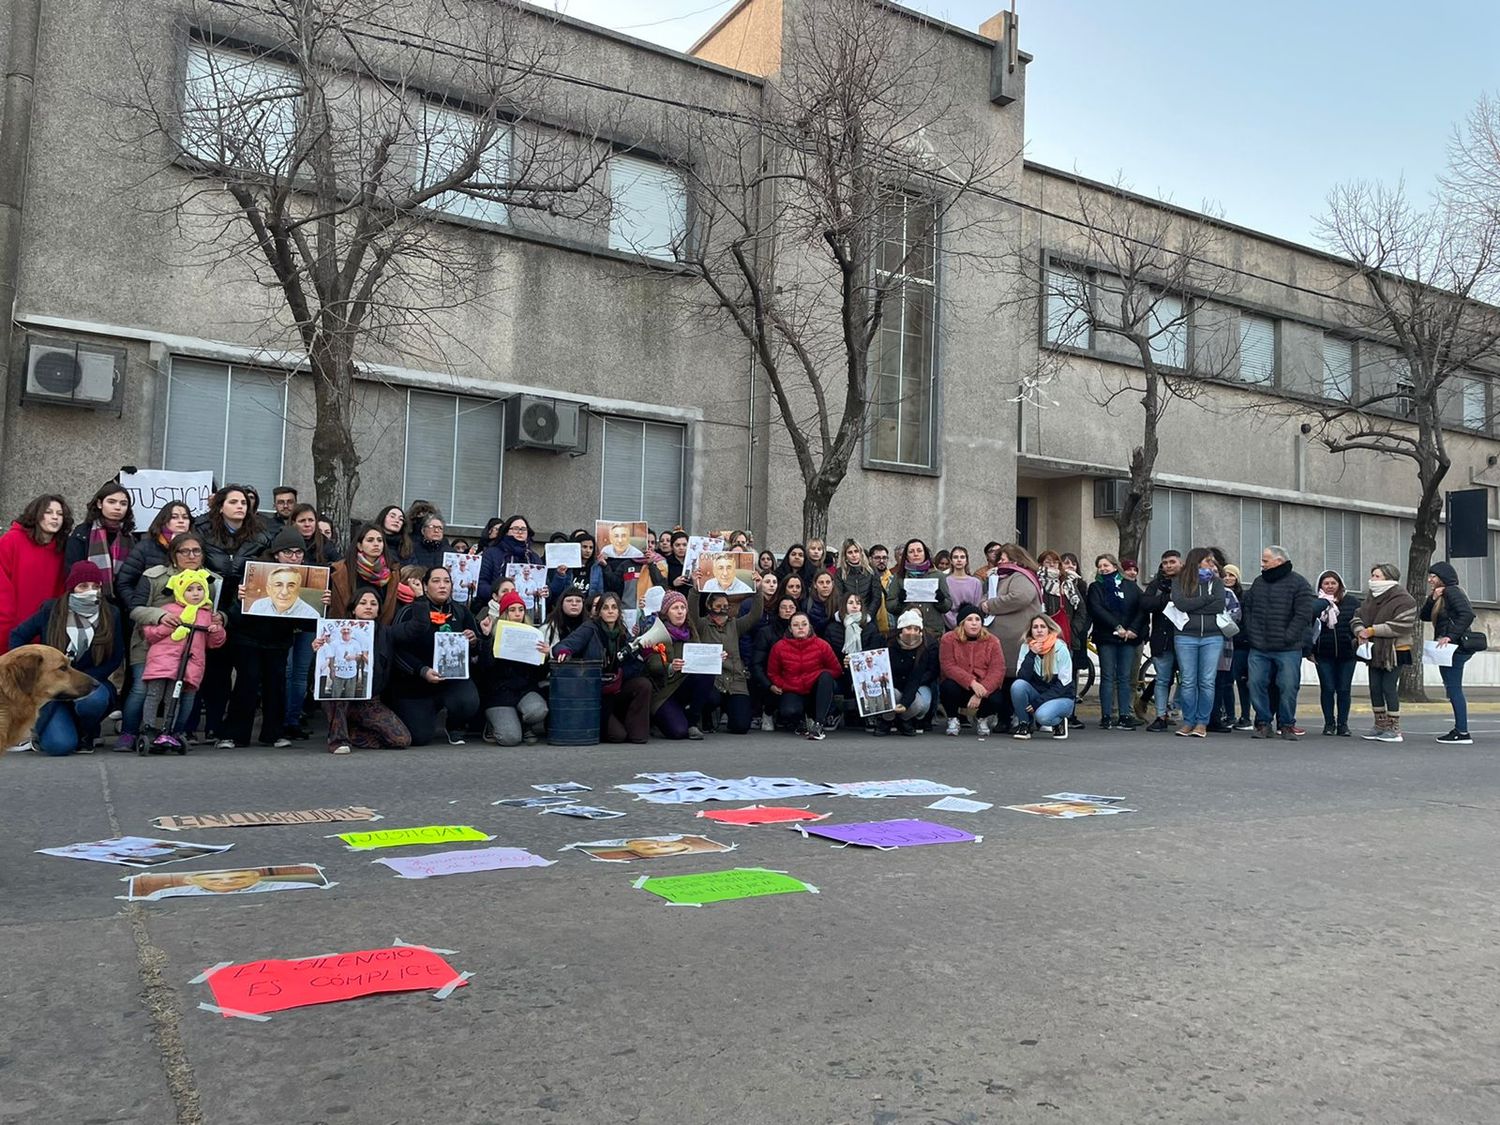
[1008,183,1241,558]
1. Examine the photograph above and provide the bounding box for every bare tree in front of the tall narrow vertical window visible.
[674,0,1019,537]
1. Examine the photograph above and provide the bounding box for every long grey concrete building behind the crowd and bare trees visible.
[0,0,1500,666]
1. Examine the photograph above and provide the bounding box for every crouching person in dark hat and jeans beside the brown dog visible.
[0,560,125,756]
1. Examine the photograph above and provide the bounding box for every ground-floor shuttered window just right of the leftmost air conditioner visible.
[162,359,288,507]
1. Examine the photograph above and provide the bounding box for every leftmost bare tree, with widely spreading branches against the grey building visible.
[114,0,603,528]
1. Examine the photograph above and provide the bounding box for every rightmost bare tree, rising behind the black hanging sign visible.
[1310,135,1500,696]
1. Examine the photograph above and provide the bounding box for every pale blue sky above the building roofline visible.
[542,0,1500,243]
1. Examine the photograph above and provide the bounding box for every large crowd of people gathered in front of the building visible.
[0,480,1484,755]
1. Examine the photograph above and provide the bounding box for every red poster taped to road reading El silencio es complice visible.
[209,945,462,1016]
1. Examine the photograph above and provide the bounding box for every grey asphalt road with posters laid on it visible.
[0,716,1500,1125]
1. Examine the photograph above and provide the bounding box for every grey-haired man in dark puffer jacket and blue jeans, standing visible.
[1244,546,1319,743]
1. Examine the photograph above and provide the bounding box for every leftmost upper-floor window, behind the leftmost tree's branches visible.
[180,44,302,173]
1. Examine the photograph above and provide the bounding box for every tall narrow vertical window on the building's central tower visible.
[870,195,938,468]
